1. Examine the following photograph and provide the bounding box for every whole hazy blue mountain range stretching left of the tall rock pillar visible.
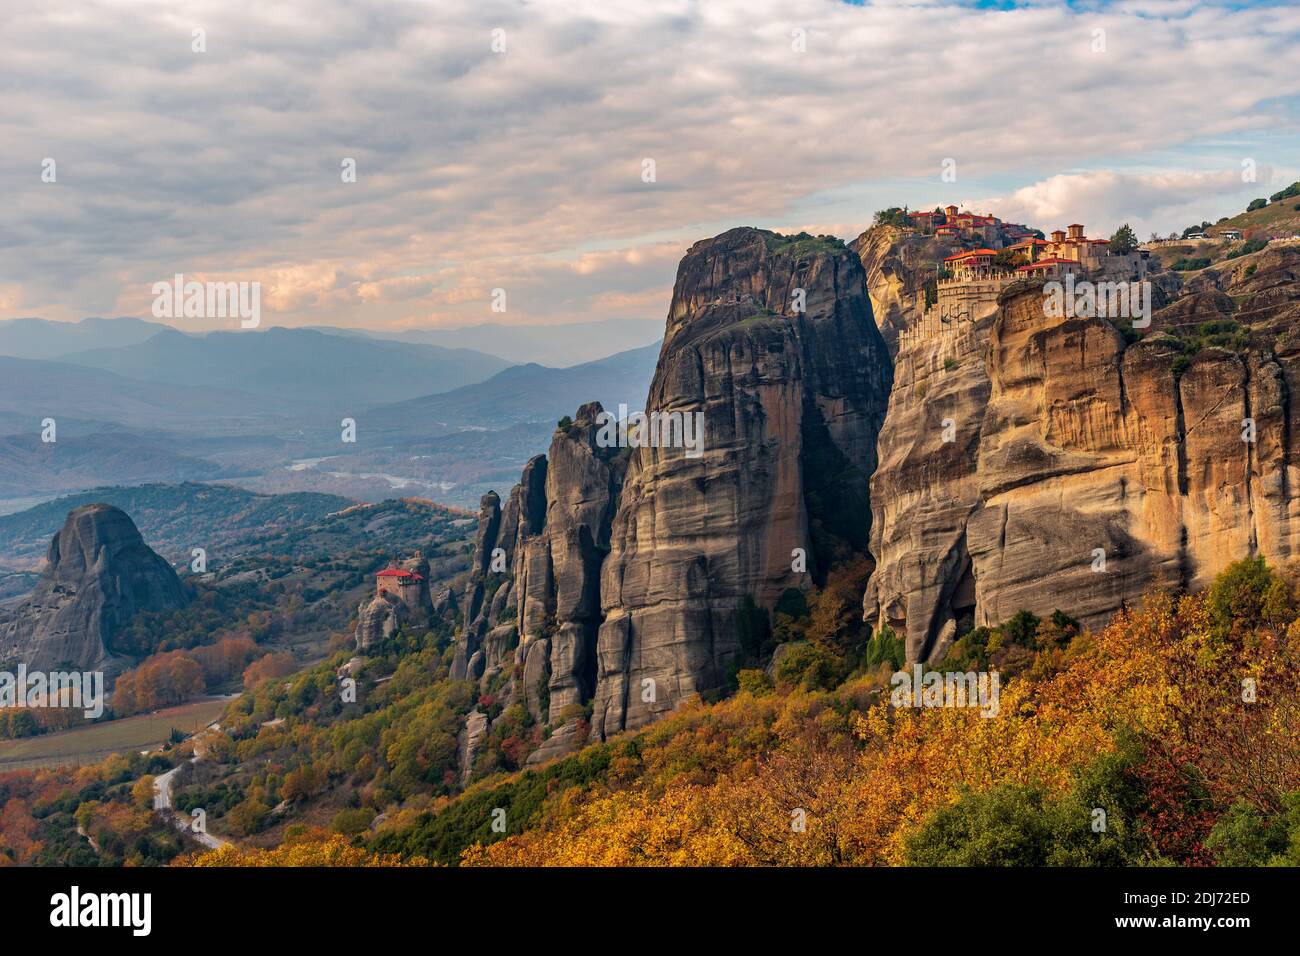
[0,319,659,510]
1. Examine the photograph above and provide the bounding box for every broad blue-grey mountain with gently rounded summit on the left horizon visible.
[64,328,507,408]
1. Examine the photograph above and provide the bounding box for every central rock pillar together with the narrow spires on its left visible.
[454,229,892,756]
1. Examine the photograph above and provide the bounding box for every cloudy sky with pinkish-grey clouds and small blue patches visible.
[0,0,1300,343]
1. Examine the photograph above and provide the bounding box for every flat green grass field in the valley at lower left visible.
[0,697,230,773]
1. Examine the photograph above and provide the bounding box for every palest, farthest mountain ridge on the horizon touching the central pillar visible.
[305,319,663,368]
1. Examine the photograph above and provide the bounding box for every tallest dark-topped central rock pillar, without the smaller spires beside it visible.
[593,229,892,734]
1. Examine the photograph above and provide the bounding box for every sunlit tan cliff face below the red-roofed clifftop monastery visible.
[865,247,1300,661]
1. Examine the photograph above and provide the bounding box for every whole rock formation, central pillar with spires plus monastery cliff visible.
[439,218,1300,761]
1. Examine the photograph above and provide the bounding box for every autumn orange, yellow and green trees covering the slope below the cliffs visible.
[111,559,1300,865]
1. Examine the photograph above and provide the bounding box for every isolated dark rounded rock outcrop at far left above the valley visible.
[0,505,187,670]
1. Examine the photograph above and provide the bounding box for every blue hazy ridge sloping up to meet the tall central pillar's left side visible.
[372,342,659,437]
